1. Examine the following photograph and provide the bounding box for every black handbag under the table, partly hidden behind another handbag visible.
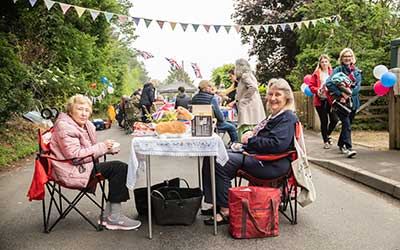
[133,177,185,216]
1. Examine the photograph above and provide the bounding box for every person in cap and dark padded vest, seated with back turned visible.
[192,80,239,143]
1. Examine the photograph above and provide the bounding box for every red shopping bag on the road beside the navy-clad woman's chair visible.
[228,186,280,239]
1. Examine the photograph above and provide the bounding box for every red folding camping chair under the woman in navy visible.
[235,122,302,225]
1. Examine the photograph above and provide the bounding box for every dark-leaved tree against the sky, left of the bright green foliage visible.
[233,0,305,82]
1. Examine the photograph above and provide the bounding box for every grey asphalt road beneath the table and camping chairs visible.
[0,128,400,250]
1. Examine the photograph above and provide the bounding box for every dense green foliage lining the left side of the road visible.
[0,0,146,122]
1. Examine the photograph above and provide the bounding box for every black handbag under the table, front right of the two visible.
[151,187,203,225]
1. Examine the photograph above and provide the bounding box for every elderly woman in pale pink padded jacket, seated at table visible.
[50,95,141,230]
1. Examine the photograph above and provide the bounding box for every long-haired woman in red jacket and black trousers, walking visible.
[309,54,338,149]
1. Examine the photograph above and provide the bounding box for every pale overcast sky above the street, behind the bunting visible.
[130,0,252,84]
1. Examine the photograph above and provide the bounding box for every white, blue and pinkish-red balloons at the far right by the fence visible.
[372,65,397,96]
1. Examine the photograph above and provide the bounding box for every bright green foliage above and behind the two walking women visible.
[289,0,400,88]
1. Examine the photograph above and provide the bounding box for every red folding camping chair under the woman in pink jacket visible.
[28,128,107,233]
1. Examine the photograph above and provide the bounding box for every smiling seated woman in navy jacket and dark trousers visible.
[202,79,298,225]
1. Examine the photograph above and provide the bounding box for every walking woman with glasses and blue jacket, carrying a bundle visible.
[326,48,361,158]
